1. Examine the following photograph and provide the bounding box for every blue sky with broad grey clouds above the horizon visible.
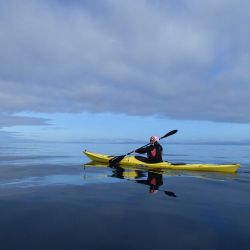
[0,0,250,143]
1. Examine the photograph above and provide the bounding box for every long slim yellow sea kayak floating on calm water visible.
[83,150,240,173]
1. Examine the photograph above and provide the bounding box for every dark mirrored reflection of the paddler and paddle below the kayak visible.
[111,166,177,197]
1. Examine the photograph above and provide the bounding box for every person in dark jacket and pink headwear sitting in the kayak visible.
[134,136,163,163]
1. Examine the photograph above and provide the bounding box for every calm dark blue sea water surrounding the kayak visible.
[0,143,250,250]
